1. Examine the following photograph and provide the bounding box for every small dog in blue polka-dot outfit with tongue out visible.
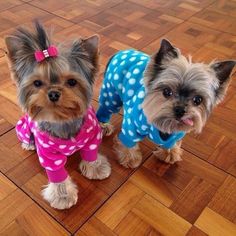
[97,39,236,168]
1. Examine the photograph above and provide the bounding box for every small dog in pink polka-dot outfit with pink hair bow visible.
[5,22,111,209]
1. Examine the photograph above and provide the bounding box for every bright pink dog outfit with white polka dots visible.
[16,107,102,183]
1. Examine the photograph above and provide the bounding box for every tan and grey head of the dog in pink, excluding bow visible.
[6,24,98,122]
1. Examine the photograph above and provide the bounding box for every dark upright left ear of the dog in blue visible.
[153,39,180,65]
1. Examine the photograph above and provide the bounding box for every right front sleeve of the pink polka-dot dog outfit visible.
[80,108,102,162]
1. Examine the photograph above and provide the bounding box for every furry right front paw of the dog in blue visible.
[153,141,182,164]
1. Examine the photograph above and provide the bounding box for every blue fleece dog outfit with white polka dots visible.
[97,49,185,149]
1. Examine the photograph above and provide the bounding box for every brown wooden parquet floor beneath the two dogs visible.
[0,0,236,236]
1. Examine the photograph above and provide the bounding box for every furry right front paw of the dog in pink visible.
[79,154,111,180]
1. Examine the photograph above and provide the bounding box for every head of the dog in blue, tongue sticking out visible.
[143,40,236,133]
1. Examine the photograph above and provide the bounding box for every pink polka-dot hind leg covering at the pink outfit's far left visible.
[16,114,34,144]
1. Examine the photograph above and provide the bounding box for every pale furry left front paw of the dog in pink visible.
[42,177,78,210]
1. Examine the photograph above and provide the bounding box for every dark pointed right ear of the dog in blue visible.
[211,60,236,104]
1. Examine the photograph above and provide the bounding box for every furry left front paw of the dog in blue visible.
[113,136,142,168]
